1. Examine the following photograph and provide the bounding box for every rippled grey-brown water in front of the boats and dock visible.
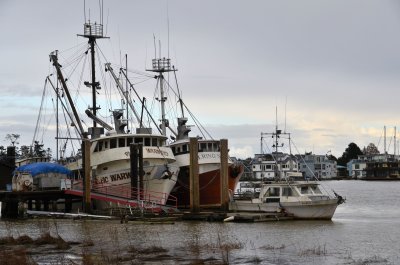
[0,181,400,265]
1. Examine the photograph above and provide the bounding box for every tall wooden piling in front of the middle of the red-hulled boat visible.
[189,137,200,213]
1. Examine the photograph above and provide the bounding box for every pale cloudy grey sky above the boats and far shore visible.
[0,0,400,158]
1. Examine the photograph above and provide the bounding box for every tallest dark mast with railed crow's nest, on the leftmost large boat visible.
[78,20,107,139]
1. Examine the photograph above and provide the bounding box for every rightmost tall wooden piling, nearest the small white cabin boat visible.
[220,139,229,211]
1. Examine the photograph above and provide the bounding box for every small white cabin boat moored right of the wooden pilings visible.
[229,127,345,220]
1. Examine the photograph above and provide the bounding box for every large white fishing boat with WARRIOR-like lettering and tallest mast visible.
[38,17,179,209]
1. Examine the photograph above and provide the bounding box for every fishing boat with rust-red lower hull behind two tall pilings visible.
[142,58,244,208]
